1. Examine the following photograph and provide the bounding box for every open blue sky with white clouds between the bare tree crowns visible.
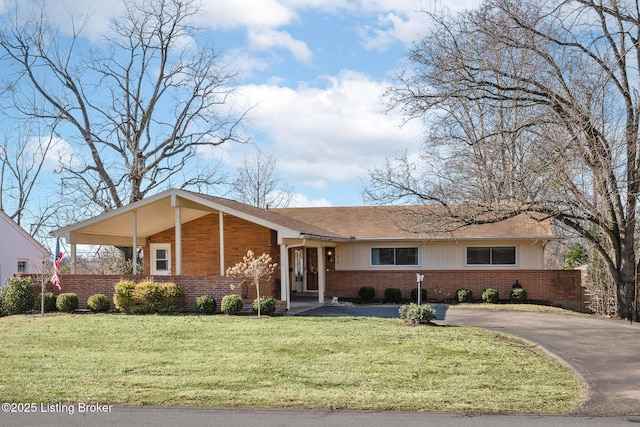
[0,0,478,206]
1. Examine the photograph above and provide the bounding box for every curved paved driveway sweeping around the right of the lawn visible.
[299,306,640,416]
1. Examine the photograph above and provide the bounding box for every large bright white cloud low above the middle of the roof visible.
[233,71,422,189]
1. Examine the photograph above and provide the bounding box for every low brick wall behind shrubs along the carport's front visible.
[34,274,286,314]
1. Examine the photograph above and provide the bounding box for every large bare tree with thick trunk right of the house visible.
[368,0,640,320]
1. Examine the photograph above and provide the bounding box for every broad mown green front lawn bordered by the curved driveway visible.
[0,314,585,413]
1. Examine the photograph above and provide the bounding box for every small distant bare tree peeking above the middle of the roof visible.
[232,148,293,209]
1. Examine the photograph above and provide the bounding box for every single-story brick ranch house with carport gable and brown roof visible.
[52,189,583,309]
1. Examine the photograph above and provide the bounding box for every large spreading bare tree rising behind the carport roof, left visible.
[0,0,244,215]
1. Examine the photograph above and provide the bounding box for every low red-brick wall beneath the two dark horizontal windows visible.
[327,268,584,311]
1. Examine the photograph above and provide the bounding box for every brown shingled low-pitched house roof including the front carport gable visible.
[52,189,553,246]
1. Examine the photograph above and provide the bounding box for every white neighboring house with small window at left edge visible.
[0,211,51,286]
